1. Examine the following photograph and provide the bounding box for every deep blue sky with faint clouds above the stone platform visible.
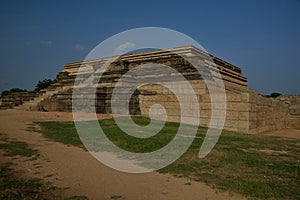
[0,0,300,94]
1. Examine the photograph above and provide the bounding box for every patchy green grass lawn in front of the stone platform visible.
[37,117,300,199]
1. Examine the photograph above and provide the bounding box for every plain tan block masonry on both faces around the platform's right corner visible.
[140,80,300,133]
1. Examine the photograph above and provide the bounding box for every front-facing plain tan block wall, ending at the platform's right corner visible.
[139,80,250,133]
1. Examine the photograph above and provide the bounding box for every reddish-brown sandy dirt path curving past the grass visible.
[0,110,243,200]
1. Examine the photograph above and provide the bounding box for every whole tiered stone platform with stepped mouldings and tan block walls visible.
[1,46,300,133]
